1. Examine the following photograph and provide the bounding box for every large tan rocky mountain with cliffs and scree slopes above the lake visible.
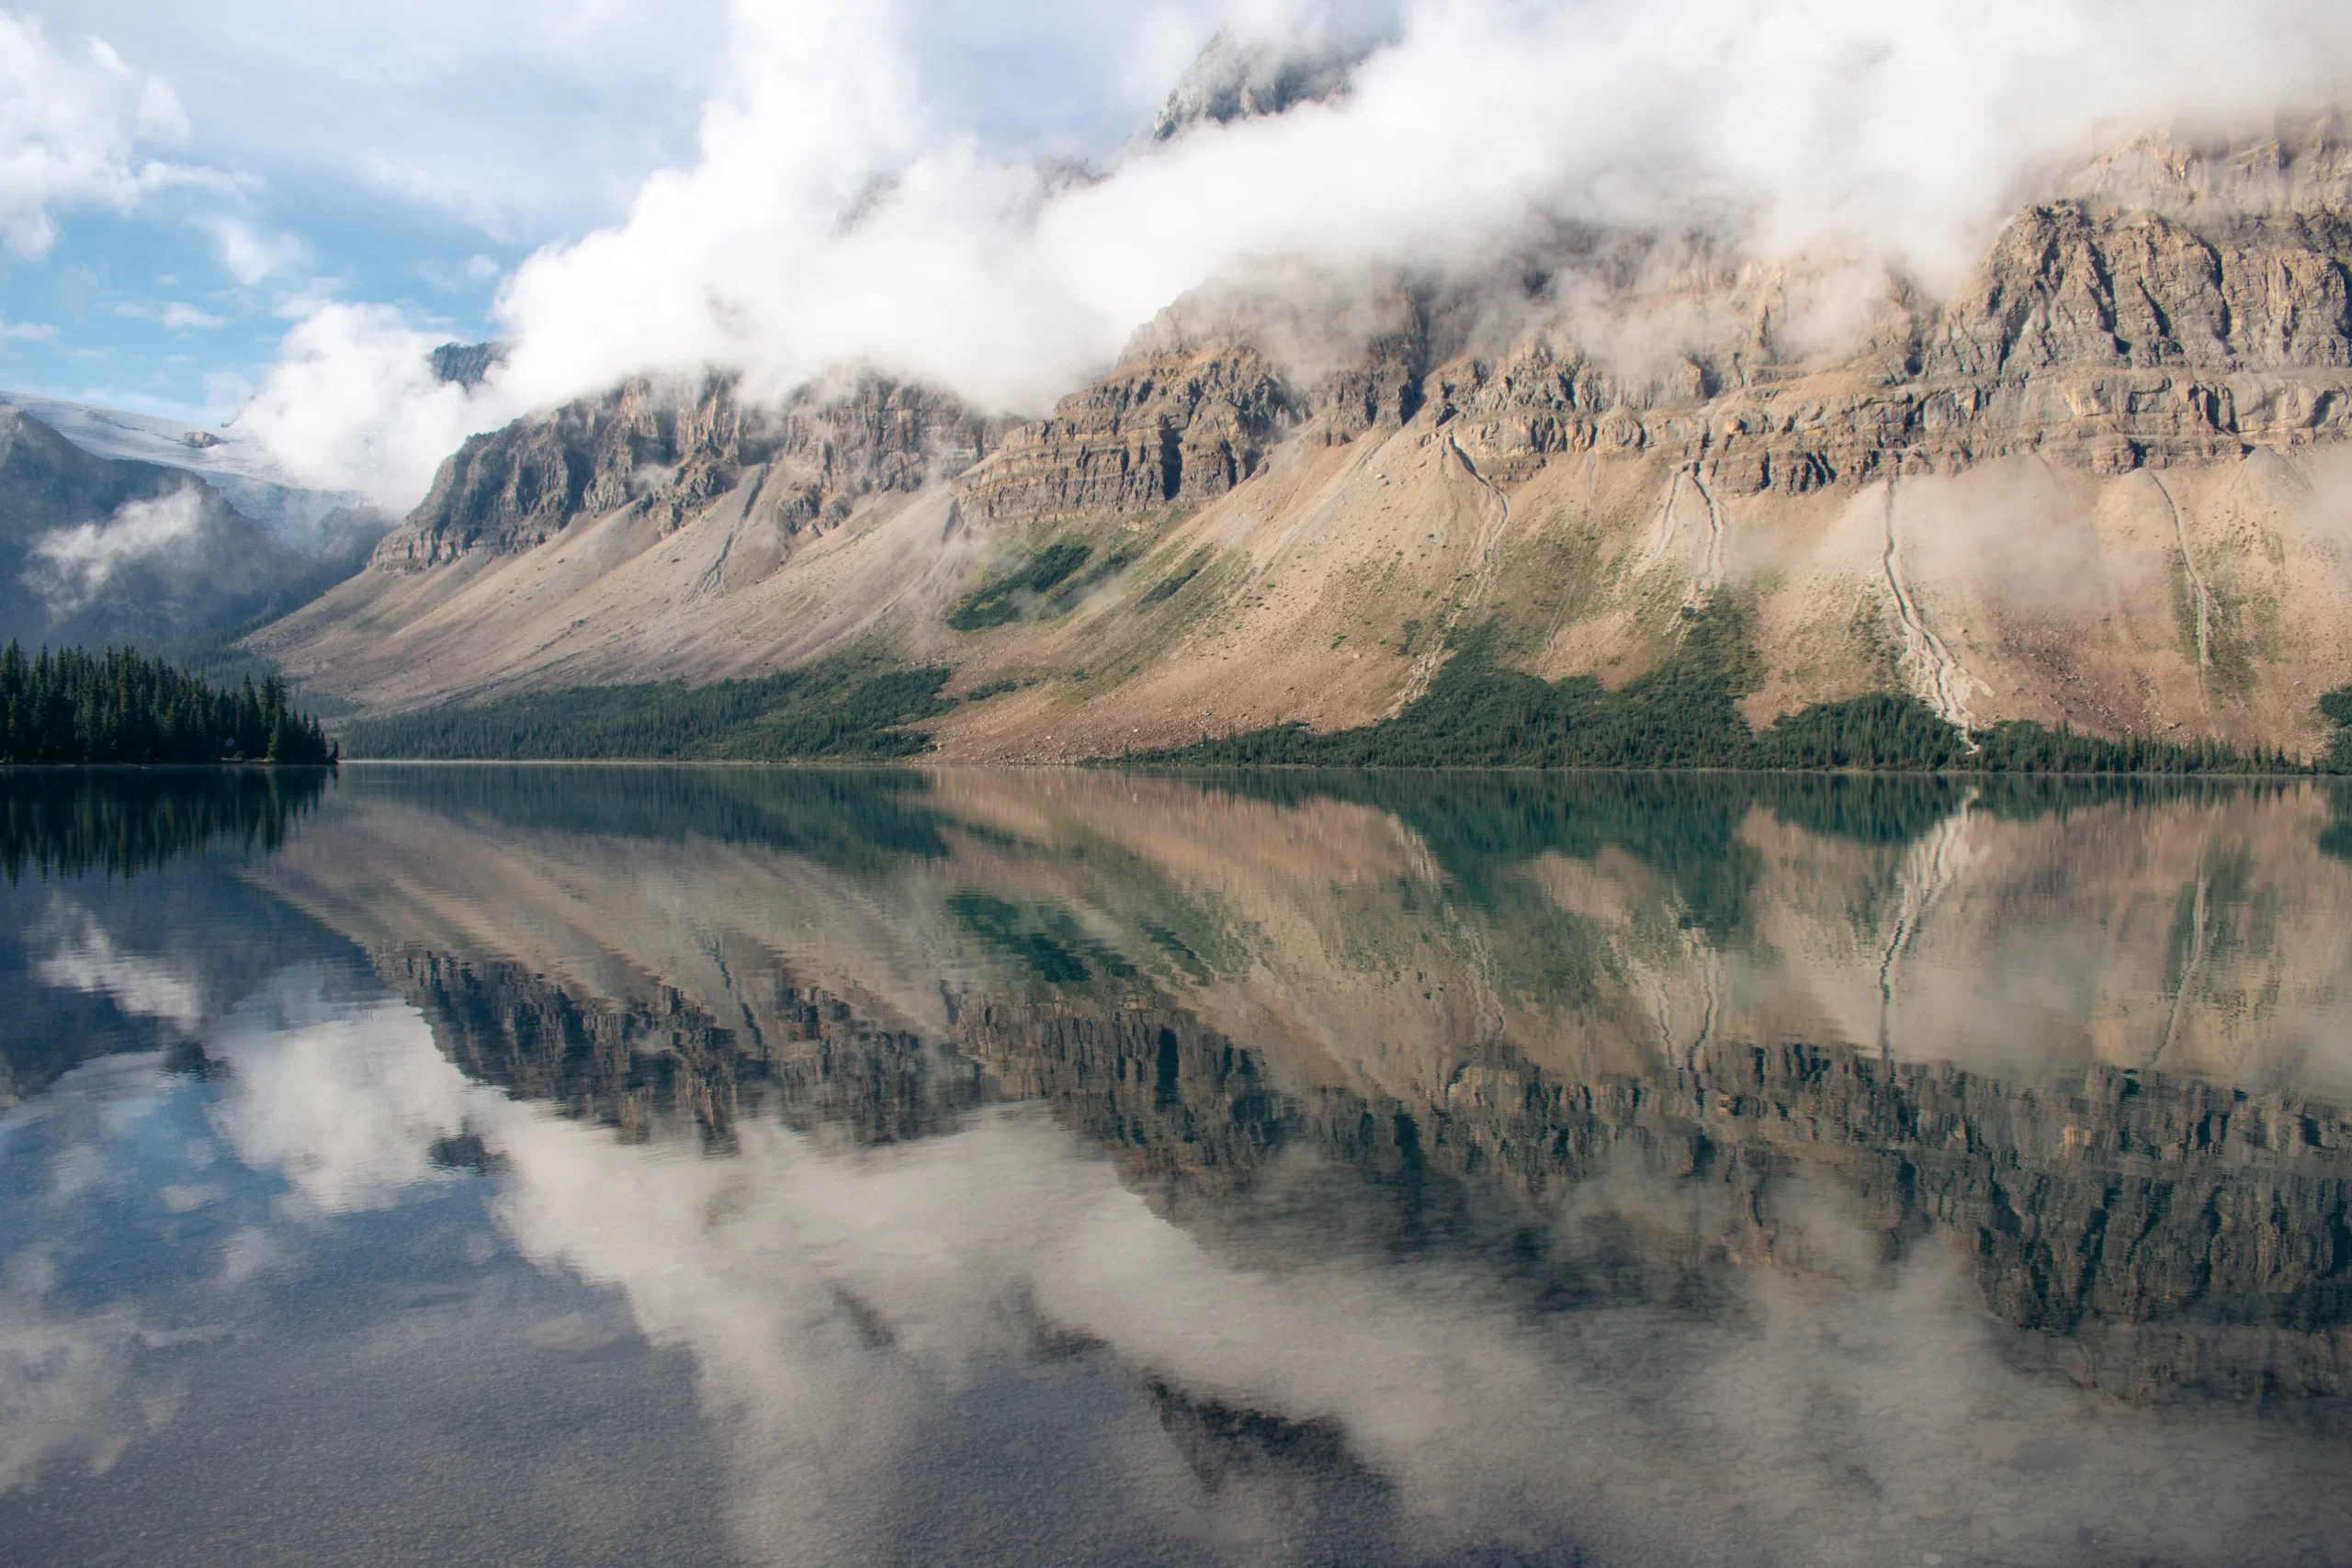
[256,123,2352,760]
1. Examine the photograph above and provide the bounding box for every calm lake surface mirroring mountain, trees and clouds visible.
[0,766,2352,1568]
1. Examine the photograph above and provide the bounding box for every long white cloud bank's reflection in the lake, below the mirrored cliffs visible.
[170,973,2347,1563]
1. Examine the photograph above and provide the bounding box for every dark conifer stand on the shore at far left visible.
[0,642,336,764]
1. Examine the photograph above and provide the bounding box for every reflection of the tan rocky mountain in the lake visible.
[243,771,2352,1425]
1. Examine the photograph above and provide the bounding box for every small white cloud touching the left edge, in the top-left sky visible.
[0,12,200,259]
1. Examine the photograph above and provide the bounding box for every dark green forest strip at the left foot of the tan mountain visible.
[344,656,955,761]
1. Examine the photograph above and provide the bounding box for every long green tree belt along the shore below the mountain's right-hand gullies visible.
[1129,597,2302,773]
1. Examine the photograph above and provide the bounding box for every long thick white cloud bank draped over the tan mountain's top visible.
[243,0,2352,508]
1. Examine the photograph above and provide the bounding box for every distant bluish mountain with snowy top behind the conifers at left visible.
[0,404,381,647]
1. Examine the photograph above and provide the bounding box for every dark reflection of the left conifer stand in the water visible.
[0,769,332,882]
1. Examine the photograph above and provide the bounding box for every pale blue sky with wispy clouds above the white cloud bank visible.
[0,0,1216,421]
